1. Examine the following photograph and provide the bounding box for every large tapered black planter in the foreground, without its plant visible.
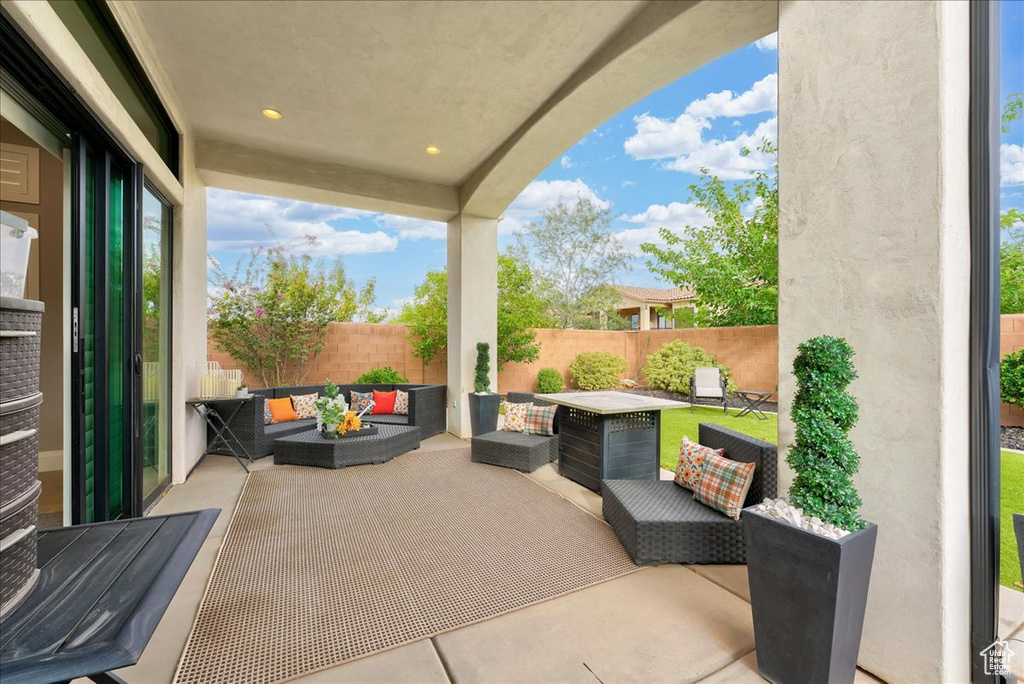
[742,509,879,684]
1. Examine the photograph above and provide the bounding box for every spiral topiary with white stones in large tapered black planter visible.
[742,336,878,684]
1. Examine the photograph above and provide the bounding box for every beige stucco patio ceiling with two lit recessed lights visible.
[119,0,777,220]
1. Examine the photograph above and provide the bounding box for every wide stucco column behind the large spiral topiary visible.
[778,0,971,682]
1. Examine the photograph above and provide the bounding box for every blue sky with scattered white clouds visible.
[208,14,1024,311]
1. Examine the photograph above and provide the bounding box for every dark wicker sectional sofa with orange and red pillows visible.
[207,384,447,459]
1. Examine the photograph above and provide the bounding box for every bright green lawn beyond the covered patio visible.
[662,407,1024,591]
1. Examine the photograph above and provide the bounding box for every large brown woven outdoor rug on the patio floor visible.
[175,448,638,684]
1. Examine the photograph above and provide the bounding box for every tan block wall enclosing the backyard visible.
[209,314,1024,425]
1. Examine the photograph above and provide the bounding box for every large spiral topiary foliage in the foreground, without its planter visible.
[785,336,864,531]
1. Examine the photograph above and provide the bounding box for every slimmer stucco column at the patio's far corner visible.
[447,214,498,438]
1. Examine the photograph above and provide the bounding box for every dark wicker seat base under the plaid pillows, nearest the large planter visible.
[601,480,746,565]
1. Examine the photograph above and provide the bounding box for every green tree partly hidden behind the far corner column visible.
[397,254,548,370]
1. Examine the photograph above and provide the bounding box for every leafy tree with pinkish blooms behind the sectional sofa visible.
[209,247,379,387]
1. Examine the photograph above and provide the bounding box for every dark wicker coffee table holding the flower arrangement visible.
[273,424,420,468]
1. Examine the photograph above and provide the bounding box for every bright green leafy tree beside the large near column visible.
[640,140,778,328]
